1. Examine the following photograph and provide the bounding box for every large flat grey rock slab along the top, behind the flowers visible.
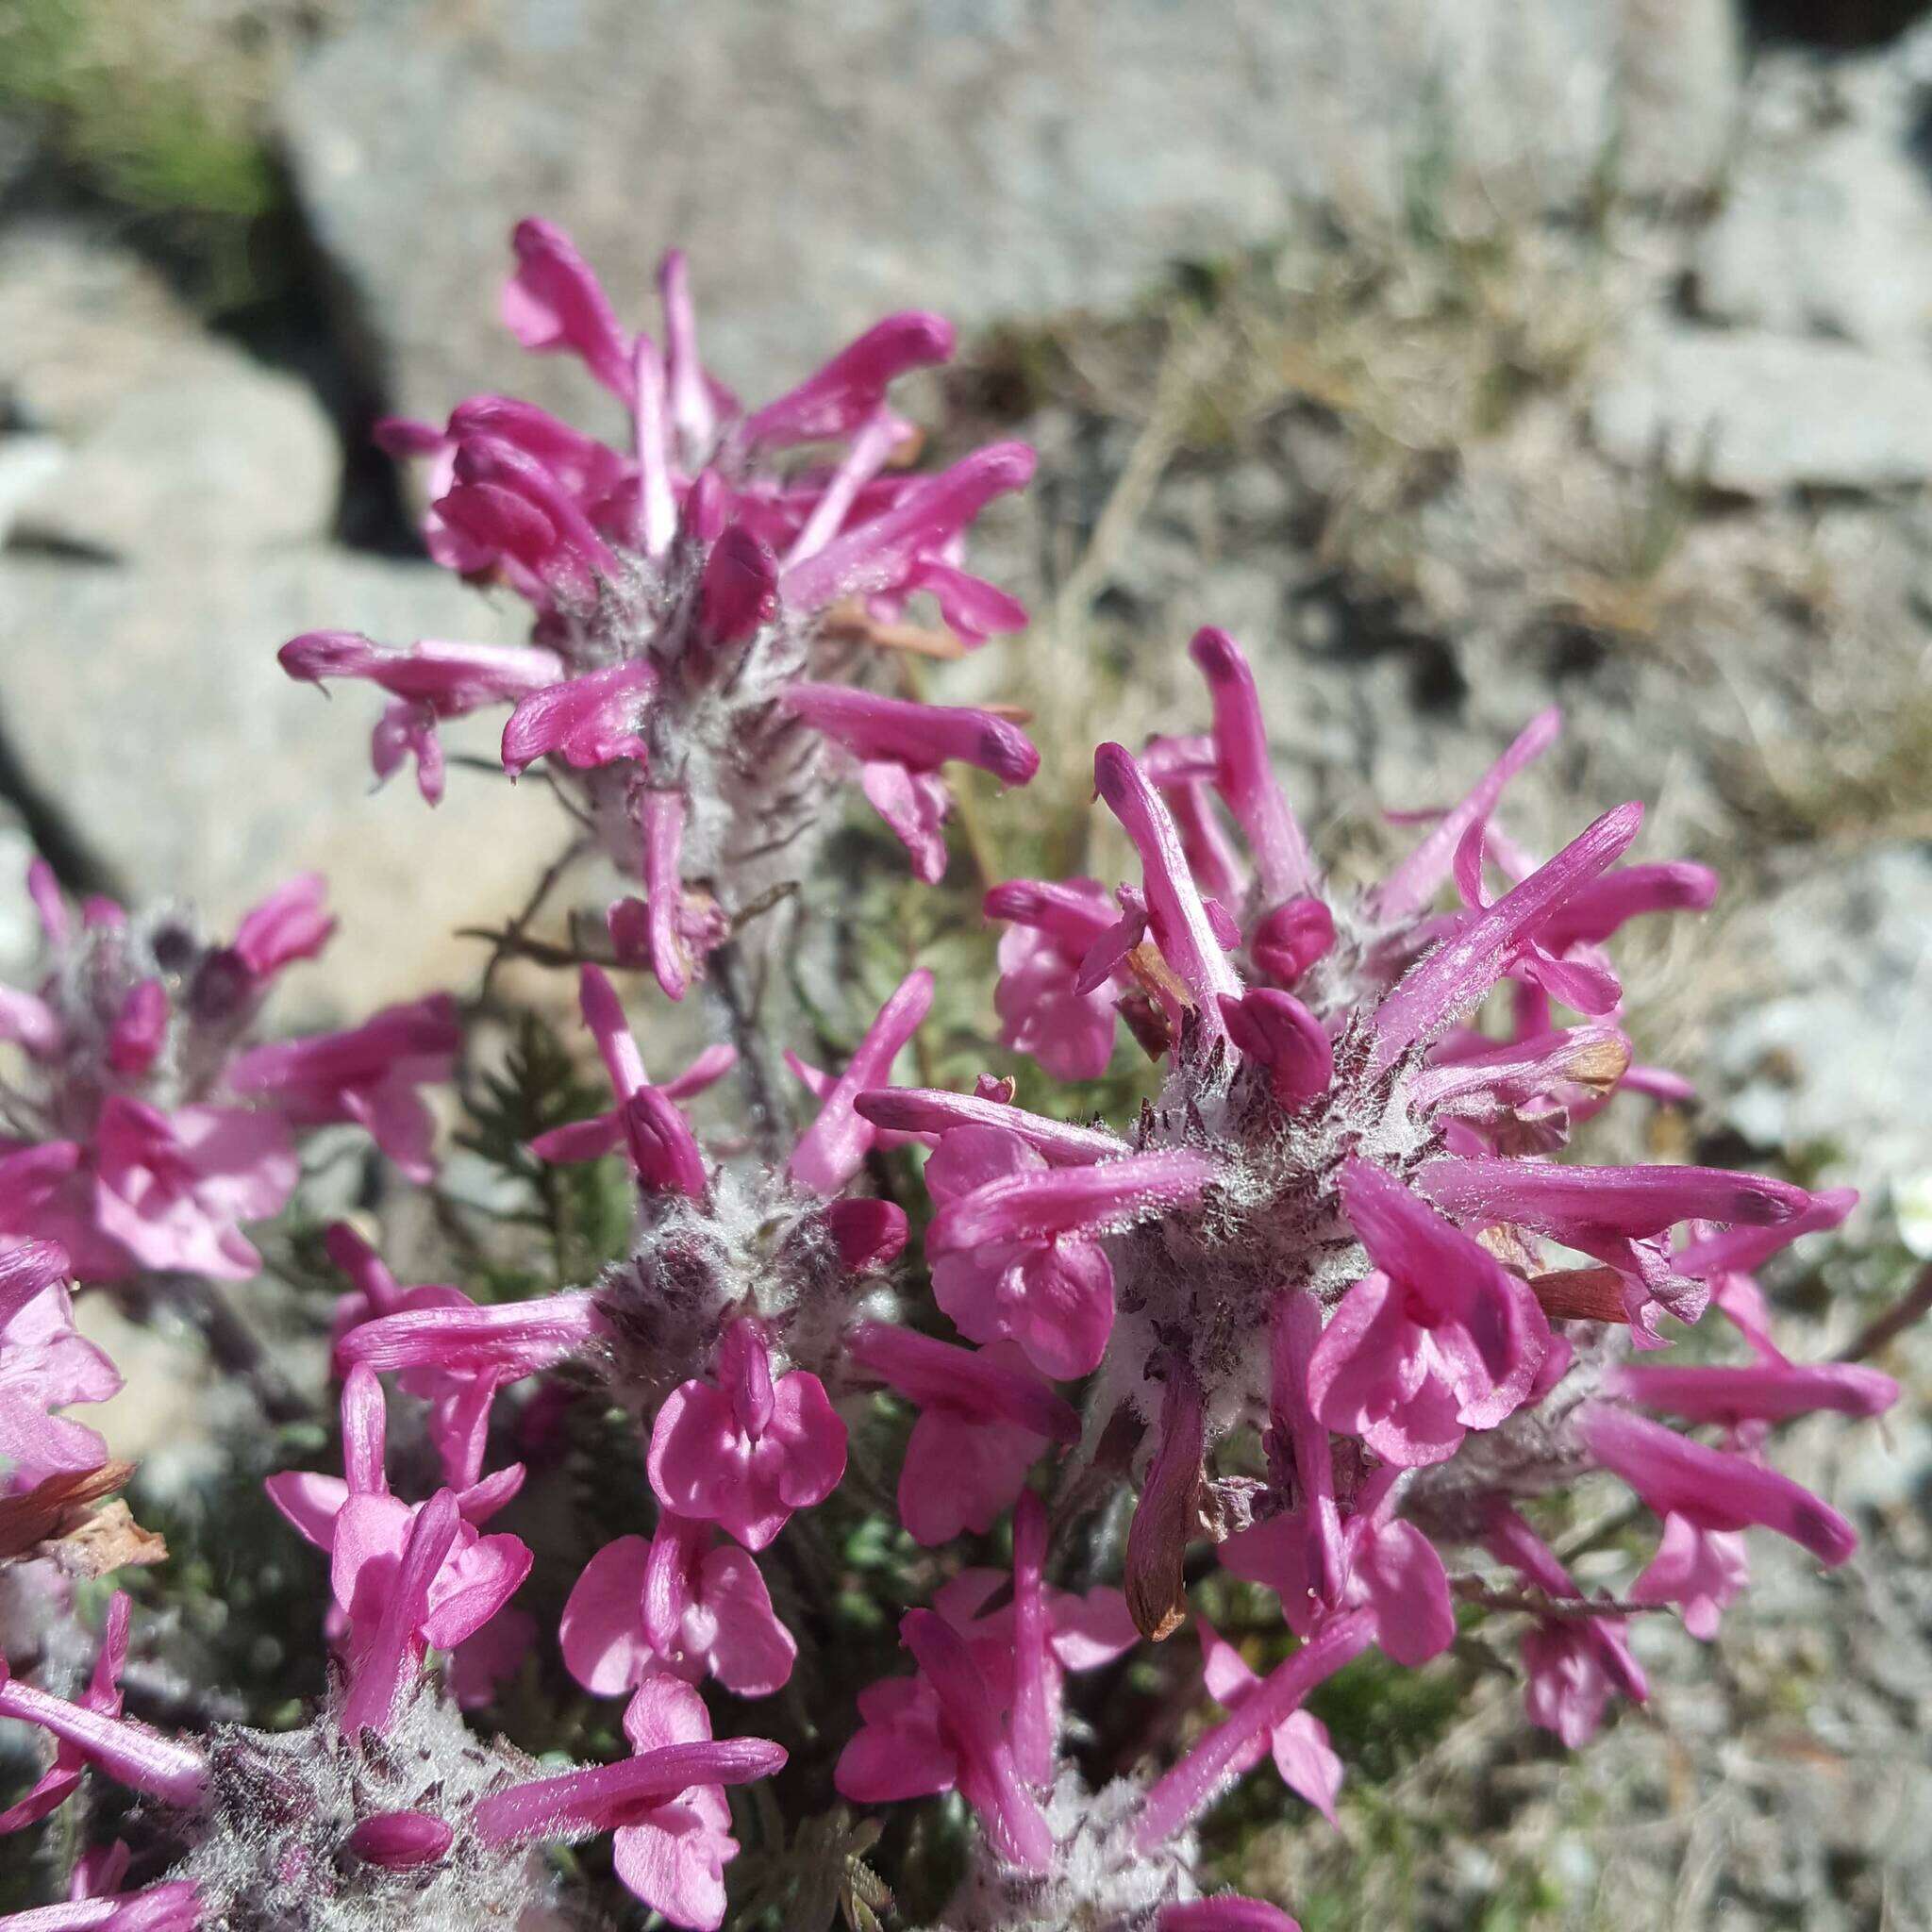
[278,0,1619,426]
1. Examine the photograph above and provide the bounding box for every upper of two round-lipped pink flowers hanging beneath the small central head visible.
[649,1320,846,1549]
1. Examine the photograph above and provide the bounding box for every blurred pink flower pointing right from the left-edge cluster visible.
[228,993,461,1180]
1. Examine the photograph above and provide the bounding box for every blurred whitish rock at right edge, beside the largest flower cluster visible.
[1712,844,1932,1189]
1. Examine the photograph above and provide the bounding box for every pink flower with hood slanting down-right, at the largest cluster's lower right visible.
[1580,1403,1858,1639]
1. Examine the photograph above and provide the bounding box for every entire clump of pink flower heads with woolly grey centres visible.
[0,223,1897,1932]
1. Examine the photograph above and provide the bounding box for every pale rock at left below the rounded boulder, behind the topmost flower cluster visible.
[0,547,566,1016]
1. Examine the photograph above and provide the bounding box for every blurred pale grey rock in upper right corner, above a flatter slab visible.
[1694,37,1932,352]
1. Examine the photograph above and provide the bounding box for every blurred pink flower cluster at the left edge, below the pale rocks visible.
[0,859,459,1306]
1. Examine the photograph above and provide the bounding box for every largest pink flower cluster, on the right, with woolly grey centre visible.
[858,630,1897,1792]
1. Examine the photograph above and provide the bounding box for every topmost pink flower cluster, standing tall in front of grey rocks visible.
[282,220,1040,999]
